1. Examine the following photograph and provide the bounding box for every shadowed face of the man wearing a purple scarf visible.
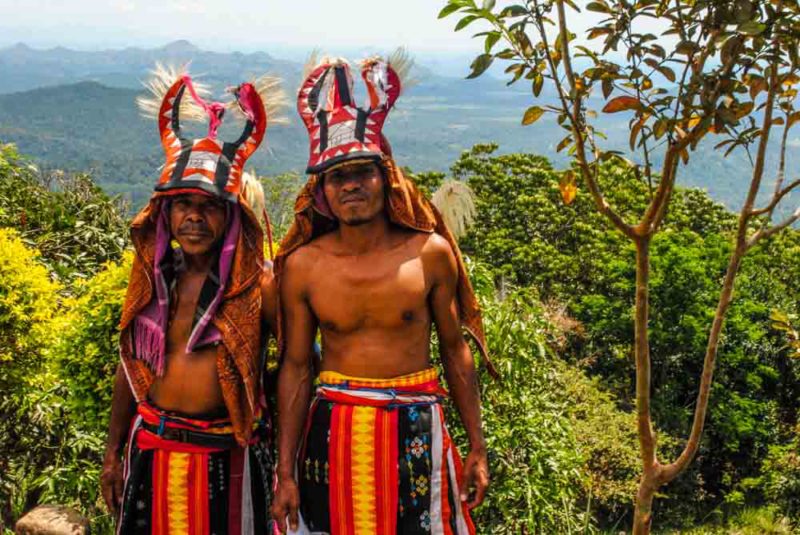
[169,194,226,255]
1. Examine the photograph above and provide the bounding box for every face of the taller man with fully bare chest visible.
[323,162,384,225]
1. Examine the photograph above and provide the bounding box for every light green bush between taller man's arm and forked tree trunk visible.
[451,262,638,534]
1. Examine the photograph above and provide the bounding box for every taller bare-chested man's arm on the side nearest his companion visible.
[272,251,317,532]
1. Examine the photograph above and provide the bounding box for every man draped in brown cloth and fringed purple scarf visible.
[101,71,276,534]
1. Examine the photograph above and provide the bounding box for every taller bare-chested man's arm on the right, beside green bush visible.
[423,235,489,508]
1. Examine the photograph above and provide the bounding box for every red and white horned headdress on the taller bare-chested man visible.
[297,51,411,173]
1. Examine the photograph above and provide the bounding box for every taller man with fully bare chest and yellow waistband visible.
[272,54,489,535]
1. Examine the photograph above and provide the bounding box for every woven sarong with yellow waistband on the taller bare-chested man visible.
[297,369,475,535]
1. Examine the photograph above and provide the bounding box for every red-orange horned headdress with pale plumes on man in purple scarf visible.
[138,66,282,202]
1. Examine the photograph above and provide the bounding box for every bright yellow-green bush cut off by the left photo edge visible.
[0,228,59,384]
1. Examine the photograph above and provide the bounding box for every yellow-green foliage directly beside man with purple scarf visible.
[52,252,133,433]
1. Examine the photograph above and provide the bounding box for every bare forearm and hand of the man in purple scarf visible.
[100,364,136,517]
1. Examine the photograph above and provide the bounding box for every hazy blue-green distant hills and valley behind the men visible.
[0,41,800,214]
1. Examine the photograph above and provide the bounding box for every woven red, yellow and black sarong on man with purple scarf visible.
[117,402,273,535]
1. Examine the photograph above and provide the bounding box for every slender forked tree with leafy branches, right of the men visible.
[439,0,800,534]
